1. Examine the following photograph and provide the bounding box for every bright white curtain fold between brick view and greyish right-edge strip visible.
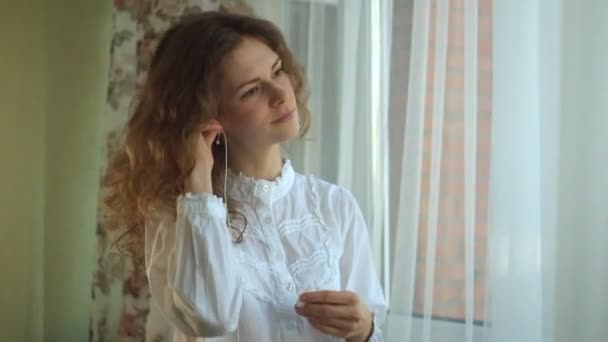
[484,1,559,342]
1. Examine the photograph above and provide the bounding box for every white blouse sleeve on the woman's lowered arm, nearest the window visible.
[340,190,387,342]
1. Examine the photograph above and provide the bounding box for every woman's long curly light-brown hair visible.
[102,12,310,261]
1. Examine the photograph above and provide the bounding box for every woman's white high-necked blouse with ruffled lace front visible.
[145,160,386,342]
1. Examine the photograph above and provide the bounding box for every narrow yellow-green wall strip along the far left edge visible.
[0,0,46,341]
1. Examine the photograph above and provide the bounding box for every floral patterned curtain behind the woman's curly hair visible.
[89,0,251,342]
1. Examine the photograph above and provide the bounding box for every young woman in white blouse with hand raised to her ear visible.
[105,12,386,342]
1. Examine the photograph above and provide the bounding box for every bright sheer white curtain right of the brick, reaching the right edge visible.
[486,0,608,342]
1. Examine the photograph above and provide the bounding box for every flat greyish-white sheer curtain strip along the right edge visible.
[545,0,608,342]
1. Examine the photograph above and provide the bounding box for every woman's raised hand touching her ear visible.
[184,120,222,194]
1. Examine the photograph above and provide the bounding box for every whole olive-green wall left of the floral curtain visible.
[0,0,112,341]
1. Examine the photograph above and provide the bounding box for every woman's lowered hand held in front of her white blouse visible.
[296,291,373,342]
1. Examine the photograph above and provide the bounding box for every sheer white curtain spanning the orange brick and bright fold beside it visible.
[387,0,556,342]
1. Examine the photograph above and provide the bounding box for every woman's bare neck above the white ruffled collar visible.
[228,144,283,181]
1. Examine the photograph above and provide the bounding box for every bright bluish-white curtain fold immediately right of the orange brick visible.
[485,1,549,342]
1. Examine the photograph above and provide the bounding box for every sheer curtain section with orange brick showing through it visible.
[386,0,494,342]
